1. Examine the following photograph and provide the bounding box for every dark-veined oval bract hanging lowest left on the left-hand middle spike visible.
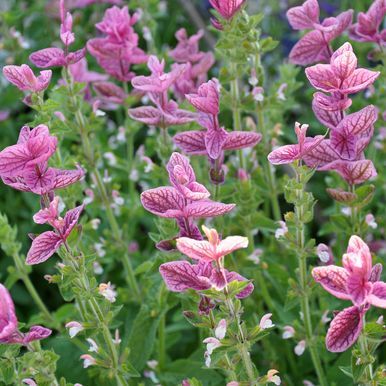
[26,231,63,265]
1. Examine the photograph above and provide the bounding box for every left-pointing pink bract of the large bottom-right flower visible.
[312,265,351,300]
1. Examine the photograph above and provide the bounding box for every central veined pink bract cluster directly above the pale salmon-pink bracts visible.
[141,153,235,243]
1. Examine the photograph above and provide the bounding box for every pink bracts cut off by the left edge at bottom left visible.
[0,284,52,345]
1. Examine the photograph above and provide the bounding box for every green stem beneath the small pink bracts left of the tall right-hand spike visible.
[295,167,328,386]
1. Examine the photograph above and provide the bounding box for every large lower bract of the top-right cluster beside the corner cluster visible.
[289,30,330,66]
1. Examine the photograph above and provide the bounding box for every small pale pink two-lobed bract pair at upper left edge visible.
[3,64,52,92]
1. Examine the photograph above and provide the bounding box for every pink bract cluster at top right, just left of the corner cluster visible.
[287,0,353,66]
